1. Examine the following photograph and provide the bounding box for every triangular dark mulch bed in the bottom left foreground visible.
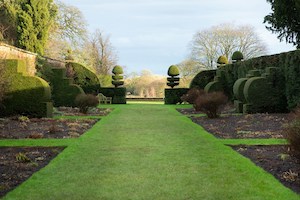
[0,147,64,198]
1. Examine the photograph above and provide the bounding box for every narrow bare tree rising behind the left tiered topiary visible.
[85,30,118,75]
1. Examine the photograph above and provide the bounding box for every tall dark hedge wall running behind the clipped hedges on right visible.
[202,50,300,110]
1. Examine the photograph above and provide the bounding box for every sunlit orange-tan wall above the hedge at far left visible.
[0,42,37,76]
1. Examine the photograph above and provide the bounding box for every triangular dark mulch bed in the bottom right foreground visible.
[233,145,300,193]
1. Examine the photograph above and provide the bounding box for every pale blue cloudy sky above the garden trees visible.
[62,0,295,75]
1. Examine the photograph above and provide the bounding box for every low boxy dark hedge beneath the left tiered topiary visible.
[99,87,126,104]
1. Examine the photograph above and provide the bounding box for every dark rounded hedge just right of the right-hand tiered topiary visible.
[190,70,216,89]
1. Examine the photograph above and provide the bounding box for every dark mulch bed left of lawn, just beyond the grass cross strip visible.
[0,118,99,139]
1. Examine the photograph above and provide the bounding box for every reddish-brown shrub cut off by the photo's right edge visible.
[284,108,300,158]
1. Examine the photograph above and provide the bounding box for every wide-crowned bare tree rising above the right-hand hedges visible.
[191,24,267,69]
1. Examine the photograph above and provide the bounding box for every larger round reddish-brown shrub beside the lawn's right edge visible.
[194,92,228,118]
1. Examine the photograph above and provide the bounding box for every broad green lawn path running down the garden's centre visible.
[4,105,300,200]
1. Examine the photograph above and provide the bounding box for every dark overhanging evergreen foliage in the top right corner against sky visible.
[264,0,300,48]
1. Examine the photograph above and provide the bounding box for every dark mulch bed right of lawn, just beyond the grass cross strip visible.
[190,114,288,139]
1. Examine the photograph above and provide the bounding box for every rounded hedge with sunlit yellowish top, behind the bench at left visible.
[66,62,101,94]
